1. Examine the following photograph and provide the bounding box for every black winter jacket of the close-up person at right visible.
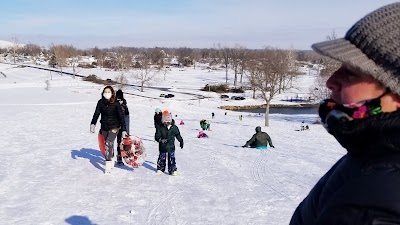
[290,111,400,225]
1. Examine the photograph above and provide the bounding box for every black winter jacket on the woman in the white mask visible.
[91,98,126,131]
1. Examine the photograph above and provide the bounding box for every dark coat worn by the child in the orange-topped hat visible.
[155,120,183,152]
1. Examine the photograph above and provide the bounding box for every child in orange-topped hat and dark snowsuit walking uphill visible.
[155,111,183,175]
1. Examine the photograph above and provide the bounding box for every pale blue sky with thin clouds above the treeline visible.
[0,0,397,49]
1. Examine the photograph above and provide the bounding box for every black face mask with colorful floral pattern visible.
[319,92,387,128]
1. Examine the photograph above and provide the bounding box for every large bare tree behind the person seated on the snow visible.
[248,47,289,126]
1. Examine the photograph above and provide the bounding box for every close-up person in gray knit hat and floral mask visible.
[290,2,400,225]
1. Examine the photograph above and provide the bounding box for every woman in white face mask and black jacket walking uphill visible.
[90,86,127,173]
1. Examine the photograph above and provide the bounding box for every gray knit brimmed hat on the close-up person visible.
[312,2,400,95]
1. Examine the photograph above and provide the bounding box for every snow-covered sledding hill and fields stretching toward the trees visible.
[0,64,345,225]
